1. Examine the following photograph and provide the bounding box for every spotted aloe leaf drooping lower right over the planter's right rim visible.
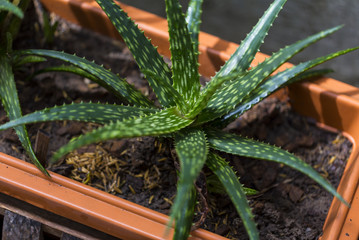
[206,129,347,204]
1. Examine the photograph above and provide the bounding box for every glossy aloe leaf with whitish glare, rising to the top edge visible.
[216,0,286,76]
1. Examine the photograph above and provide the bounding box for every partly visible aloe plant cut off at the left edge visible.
[0,0,49,176]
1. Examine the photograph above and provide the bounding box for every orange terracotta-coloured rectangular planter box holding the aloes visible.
[0,0,359,240]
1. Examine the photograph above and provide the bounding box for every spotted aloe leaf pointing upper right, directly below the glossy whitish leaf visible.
[197,26,341,122]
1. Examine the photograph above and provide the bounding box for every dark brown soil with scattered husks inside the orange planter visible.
[0,4,351,239]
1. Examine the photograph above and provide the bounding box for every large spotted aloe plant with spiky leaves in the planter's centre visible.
[0,0,354,239]
